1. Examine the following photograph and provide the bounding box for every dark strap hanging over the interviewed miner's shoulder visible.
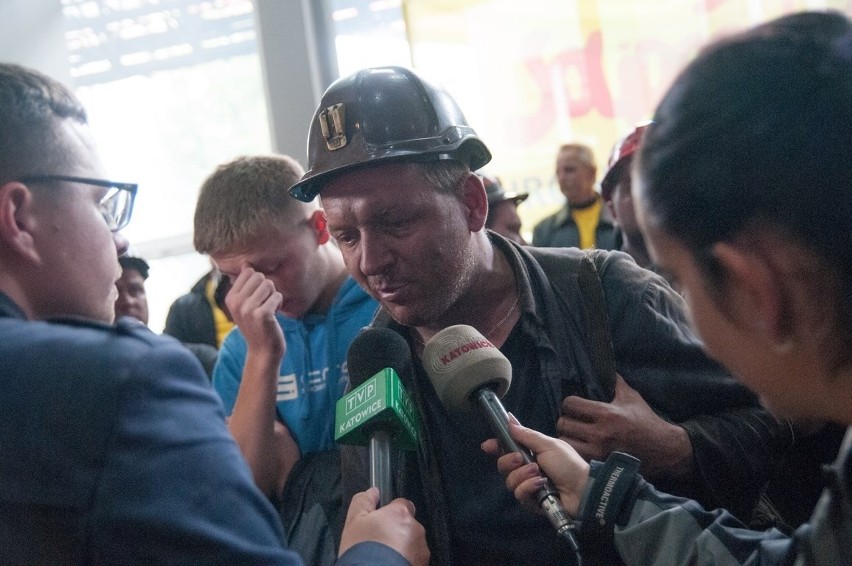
[529,248,616,402]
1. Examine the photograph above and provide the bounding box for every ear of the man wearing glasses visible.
[0,181,39,261]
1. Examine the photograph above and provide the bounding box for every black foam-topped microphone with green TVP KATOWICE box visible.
[334,328,419,505]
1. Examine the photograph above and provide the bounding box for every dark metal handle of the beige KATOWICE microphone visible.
[471,387,579,552]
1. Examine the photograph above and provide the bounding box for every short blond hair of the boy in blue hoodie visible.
[193,155,319,255]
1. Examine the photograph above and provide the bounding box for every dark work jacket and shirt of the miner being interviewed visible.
[343,235,790,566]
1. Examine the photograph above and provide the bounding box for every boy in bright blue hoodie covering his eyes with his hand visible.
[194,156,377,558]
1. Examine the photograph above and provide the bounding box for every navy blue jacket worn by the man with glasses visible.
[0,293,407,566]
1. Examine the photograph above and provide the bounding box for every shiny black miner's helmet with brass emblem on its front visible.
[290,67,491,202]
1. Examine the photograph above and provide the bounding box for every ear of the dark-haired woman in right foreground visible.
[713,243,792,345]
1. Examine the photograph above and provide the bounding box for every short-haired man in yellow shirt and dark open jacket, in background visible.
[533,143,620,250]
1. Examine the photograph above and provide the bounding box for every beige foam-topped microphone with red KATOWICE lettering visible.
[423,324,579,553]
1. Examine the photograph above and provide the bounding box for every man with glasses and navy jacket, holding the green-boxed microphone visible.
[0,64,428,564]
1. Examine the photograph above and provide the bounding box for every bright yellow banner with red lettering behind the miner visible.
[404,0,852,231]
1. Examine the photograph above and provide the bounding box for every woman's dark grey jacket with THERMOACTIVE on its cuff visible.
[578,428,852,566]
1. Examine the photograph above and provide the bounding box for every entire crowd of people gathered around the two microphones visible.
[0,7,852,566]
